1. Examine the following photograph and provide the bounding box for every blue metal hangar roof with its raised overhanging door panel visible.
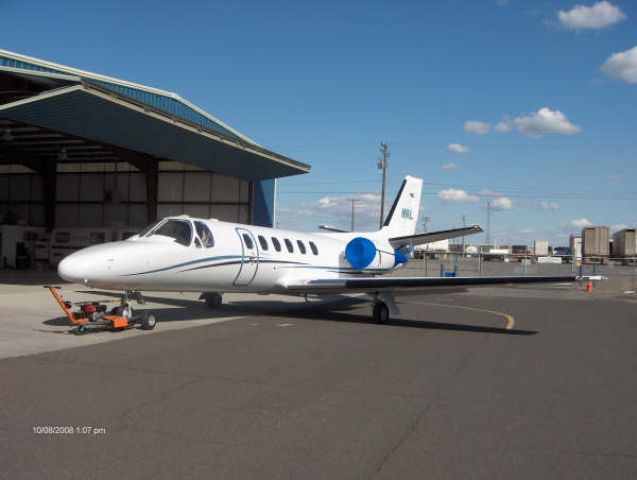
[0,50,310,180]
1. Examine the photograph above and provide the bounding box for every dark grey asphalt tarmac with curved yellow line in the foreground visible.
[0,288,637,479]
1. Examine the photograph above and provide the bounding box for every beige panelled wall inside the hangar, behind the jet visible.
[0,162,250,229]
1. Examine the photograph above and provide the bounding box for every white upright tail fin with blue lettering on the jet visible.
[382,175,422,237]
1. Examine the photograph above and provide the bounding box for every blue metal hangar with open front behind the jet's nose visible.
[0,50,310,268]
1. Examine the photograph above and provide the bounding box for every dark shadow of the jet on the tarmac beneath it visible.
[43,290,538,336]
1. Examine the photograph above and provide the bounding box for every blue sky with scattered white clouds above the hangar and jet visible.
[0,0,637,244]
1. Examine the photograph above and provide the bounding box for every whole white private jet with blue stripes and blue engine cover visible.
[58,176,575,323]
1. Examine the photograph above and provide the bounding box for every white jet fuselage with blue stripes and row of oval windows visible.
[58,216,399,292]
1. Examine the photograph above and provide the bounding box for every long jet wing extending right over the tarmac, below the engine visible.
[283,275,577,294]
